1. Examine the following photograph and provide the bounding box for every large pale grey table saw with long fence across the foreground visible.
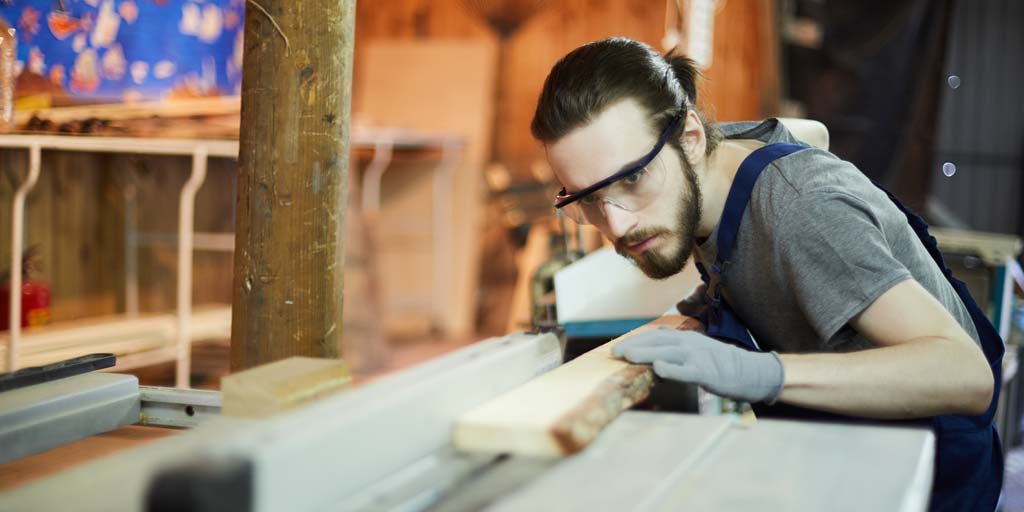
[0,334,935,511]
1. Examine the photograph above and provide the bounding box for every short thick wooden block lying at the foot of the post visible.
[220,357,352,418]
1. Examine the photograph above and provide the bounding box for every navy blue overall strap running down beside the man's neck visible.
[696,143,807,351]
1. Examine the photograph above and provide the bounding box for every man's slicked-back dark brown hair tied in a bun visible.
[530,37,722,155]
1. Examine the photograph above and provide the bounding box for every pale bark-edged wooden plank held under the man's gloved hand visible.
[454,315,693,457]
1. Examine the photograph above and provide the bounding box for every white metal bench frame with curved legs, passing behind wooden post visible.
[0,127,463,387]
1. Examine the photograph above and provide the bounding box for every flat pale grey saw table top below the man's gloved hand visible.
[473,411,934,512]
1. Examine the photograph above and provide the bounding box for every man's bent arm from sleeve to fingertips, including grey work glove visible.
[611,279,992,419]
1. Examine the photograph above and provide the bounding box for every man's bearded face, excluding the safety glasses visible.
[548,99,700,279]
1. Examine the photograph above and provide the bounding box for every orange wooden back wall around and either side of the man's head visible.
[355,0,777,177]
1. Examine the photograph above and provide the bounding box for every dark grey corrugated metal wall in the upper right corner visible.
[932,0,1024,233]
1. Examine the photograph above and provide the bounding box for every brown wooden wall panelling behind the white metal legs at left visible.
[0,150,234,322]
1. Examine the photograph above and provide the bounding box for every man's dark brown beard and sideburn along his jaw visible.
[615,151,700,280]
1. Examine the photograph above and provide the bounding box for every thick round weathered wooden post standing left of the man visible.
[231,0,355,371]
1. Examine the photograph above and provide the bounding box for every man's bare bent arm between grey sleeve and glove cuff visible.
[779,280,993,419]
